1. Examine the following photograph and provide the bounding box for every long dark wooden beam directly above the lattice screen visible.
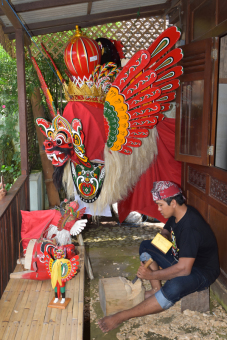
[3,4,167,35]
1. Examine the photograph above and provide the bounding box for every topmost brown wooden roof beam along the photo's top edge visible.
[11,0,101,13]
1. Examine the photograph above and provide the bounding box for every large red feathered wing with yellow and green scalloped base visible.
[104,26,183,154]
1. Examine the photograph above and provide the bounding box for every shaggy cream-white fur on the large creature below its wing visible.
[62,127,158,214]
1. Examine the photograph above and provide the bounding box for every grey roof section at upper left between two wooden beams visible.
[1,0,87,27]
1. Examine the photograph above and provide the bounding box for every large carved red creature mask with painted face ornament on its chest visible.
[36,114,105,203]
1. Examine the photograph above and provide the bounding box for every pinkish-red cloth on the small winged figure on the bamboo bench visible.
[21,210,75,249]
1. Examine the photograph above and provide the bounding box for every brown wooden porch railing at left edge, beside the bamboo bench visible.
[0,175,29,297]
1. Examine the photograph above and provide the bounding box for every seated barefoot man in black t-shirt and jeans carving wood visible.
[99,181,220,332]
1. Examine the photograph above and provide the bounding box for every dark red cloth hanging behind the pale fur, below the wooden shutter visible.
[118,118,181,223]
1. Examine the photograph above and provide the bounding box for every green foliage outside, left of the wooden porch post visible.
[0,46,20,190]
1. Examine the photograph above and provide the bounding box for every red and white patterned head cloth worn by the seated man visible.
[151,181,182,201]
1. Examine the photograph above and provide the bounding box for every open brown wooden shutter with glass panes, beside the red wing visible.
[175,38,218,165]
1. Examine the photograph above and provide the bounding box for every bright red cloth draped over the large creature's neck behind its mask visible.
[63,102,106,161]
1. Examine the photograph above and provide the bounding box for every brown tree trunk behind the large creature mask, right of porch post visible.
[31,88,60,208]
